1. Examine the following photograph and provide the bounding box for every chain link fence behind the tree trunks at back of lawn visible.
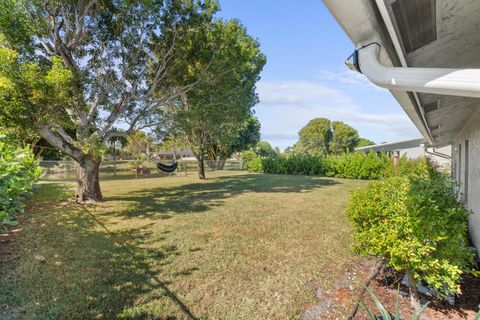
[40,159,243,181]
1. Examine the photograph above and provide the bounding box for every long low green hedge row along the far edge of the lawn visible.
[242,151,391,179]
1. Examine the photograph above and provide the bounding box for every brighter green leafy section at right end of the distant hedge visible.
[326,152,391,180]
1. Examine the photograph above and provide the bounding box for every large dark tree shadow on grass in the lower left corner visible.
[0,201,198,320]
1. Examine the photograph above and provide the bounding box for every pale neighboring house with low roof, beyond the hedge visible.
[355,138,452,169]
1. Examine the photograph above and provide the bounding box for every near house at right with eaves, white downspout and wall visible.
[324,0,480,251]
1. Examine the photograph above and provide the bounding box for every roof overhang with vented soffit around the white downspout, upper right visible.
[324,0,480,147]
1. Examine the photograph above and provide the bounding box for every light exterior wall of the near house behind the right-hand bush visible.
[452,111,480,255]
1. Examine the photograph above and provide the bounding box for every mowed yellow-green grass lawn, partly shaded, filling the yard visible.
[0,172,365,319]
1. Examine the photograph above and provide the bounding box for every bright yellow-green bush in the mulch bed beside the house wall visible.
[347,158,474,294]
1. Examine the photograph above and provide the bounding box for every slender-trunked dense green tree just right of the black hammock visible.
[167,20,265,179]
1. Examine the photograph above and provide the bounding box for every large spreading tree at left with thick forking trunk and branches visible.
[0,0,217,200]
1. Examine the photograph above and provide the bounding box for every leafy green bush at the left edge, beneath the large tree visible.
[0,137,41,226]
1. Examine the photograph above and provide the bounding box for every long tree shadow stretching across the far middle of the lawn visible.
[105,174,340,219]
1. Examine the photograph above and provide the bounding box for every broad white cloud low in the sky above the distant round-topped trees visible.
[255,79,419,148]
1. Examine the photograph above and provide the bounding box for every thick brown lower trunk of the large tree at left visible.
[75,157,102,201]
